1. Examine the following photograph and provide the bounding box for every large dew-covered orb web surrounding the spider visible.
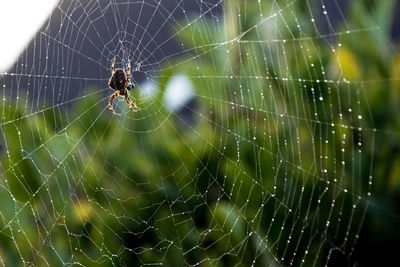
[0,0,376,266]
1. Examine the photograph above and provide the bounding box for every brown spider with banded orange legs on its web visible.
[108,57,140,116]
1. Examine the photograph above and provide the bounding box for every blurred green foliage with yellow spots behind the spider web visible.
[0,0,400,266]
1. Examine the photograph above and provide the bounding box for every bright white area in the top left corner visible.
[0,0,59,75]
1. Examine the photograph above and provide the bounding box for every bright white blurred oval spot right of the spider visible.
[164,74,194,111]
